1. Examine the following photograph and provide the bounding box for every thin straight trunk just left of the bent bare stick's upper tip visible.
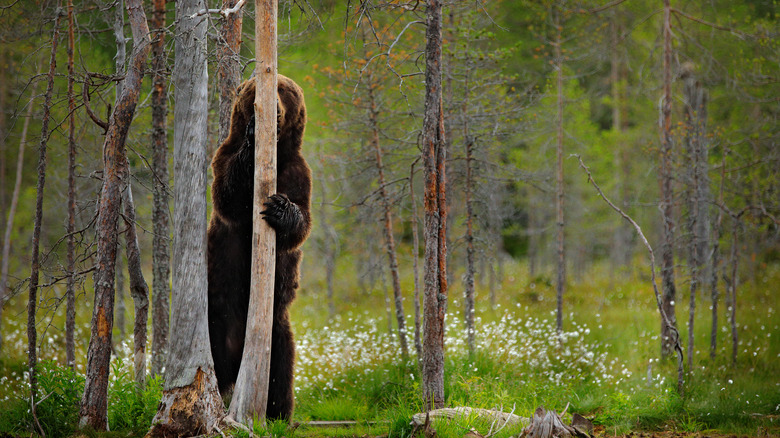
[553,10,566,334]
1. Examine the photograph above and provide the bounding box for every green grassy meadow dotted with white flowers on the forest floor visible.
[0,258,780,437]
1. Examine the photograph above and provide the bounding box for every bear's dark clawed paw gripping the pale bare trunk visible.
[261,193,307,250]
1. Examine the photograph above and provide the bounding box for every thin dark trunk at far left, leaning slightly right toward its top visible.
[27,12,61,436]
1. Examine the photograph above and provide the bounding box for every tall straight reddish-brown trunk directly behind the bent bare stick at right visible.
[659,0,677,358]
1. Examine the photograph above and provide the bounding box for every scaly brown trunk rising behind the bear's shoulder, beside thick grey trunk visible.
[217,0,243,144]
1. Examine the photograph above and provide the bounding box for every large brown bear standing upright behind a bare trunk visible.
[208,75,311,419]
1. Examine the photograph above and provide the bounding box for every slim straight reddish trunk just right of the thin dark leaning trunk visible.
[65,0,76,369]
